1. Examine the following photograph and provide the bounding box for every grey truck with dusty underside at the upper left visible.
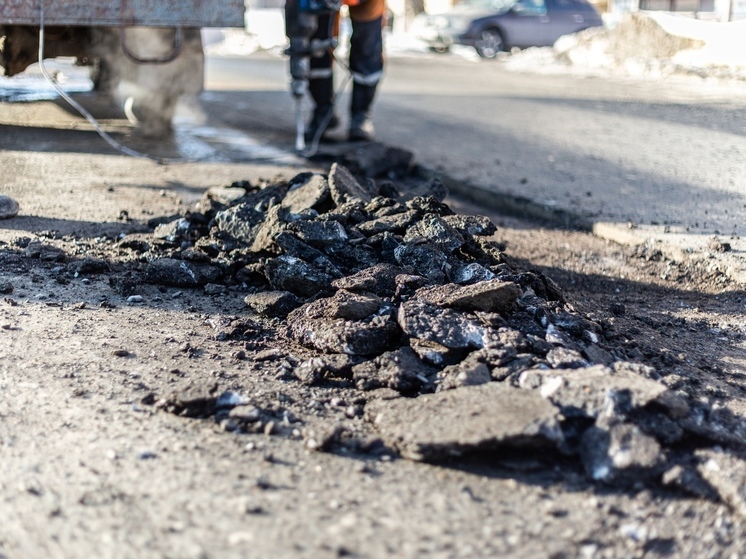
[0,0,245,137]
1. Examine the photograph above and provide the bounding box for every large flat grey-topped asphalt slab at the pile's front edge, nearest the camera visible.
[366,383,564,462]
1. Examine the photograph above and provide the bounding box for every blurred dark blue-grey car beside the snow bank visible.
[413,0,603,58]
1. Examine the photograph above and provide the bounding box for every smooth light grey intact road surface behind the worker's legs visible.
[202,50,746,234]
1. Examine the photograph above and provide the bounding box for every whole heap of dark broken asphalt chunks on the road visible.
[8,158,746,509]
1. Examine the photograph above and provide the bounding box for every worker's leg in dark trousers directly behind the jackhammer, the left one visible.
[306,14,339,142]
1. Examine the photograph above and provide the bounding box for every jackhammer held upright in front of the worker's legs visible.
[285,0,342,151]
